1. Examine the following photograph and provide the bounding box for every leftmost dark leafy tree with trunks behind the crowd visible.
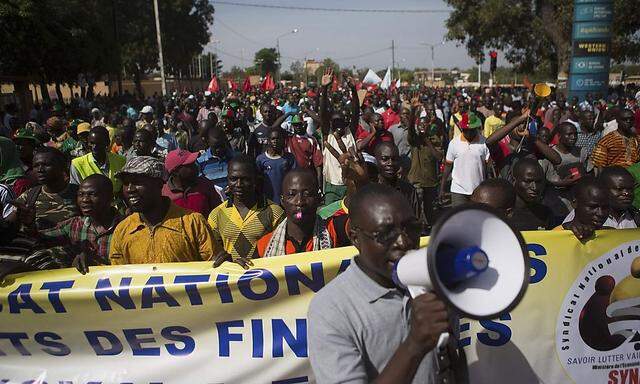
[0,0,117,99]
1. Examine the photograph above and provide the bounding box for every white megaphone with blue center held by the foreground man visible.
[393,204,530,344]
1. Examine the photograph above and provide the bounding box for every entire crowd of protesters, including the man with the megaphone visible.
[0,70,640,382]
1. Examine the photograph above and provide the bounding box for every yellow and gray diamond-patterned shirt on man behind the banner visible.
[209,200,284,260]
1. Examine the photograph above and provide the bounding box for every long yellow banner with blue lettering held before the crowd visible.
[0,230,640,384]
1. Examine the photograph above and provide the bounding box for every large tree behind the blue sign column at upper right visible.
[446,0,640,81]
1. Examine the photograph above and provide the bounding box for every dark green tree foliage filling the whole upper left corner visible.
[0,0,214,95]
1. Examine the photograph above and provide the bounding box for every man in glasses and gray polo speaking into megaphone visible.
[308,184,466,384]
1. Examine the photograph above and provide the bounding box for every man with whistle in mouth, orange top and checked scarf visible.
[257,168,349,257]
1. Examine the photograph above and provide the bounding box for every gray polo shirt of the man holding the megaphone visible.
[308,260,435,384]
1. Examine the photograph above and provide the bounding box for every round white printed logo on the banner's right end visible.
[556,241,640,384]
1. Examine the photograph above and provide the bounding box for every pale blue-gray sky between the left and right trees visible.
[205,0,504,70]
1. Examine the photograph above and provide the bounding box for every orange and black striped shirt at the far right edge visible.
[591,131,640,168]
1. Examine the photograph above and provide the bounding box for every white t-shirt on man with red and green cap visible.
[446,134,489,195]
